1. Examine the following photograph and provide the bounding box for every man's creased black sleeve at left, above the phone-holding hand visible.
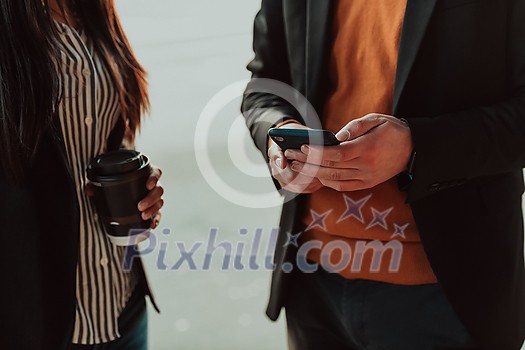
[241,0,304,160]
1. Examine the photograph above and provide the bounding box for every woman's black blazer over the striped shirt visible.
[0,121,156,350]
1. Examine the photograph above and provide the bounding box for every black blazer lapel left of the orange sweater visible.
[305,0,332,102]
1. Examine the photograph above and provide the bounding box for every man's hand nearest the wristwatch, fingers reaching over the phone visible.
[286,114,413,192]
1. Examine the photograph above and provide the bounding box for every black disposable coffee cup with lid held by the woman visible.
[87,150,152,246]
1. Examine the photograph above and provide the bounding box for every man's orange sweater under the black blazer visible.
[302,0,436,285]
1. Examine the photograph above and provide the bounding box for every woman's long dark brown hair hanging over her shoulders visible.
[0,0,149,183]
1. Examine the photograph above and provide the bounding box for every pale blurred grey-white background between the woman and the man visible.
[117,0,286,350]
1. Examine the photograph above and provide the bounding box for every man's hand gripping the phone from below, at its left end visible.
[268,123,323,194]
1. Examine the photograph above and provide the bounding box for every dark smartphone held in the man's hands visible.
[268,128,341,151]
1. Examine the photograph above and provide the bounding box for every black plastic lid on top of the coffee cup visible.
[88,150,147,177]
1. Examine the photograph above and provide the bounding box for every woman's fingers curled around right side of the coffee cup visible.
[138,168,164,229]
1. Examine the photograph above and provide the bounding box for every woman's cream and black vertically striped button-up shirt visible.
[51,22,136,345]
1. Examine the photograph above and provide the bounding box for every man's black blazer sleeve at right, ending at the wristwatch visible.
[408,0,525,202]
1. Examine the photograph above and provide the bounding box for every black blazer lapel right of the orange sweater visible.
[394,0,437,113]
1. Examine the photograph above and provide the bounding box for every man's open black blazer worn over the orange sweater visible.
[242,0,525,350]
